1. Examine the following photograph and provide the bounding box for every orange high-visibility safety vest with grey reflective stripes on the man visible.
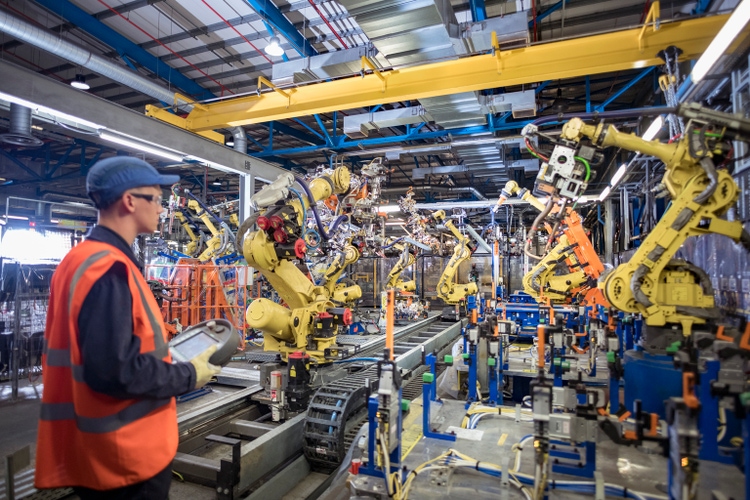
[34,240,178,490]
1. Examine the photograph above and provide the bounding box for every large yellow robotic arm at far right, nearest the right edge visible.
[548,104,750,336]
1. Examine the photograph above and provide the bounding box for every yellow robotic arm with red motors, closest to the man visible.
[241,167,361,361]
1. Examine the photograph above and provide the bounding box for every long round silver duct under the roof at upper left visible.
[0,10,191,110]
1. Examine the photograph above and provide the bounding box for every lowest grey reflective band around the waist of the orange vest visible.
[40,398,172,434]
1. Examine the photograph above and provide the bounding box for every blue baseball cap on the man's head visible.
[86,156,180,207]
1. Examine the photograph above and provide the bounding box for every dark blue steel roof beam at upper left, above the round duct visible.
[35,0,216,101]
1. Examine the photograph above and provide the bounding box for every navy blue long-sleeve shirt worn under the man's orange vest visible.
[78,226,195,399]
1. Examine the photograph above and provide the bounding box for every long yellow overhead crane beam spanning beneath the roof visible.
[146,15,729,133]
